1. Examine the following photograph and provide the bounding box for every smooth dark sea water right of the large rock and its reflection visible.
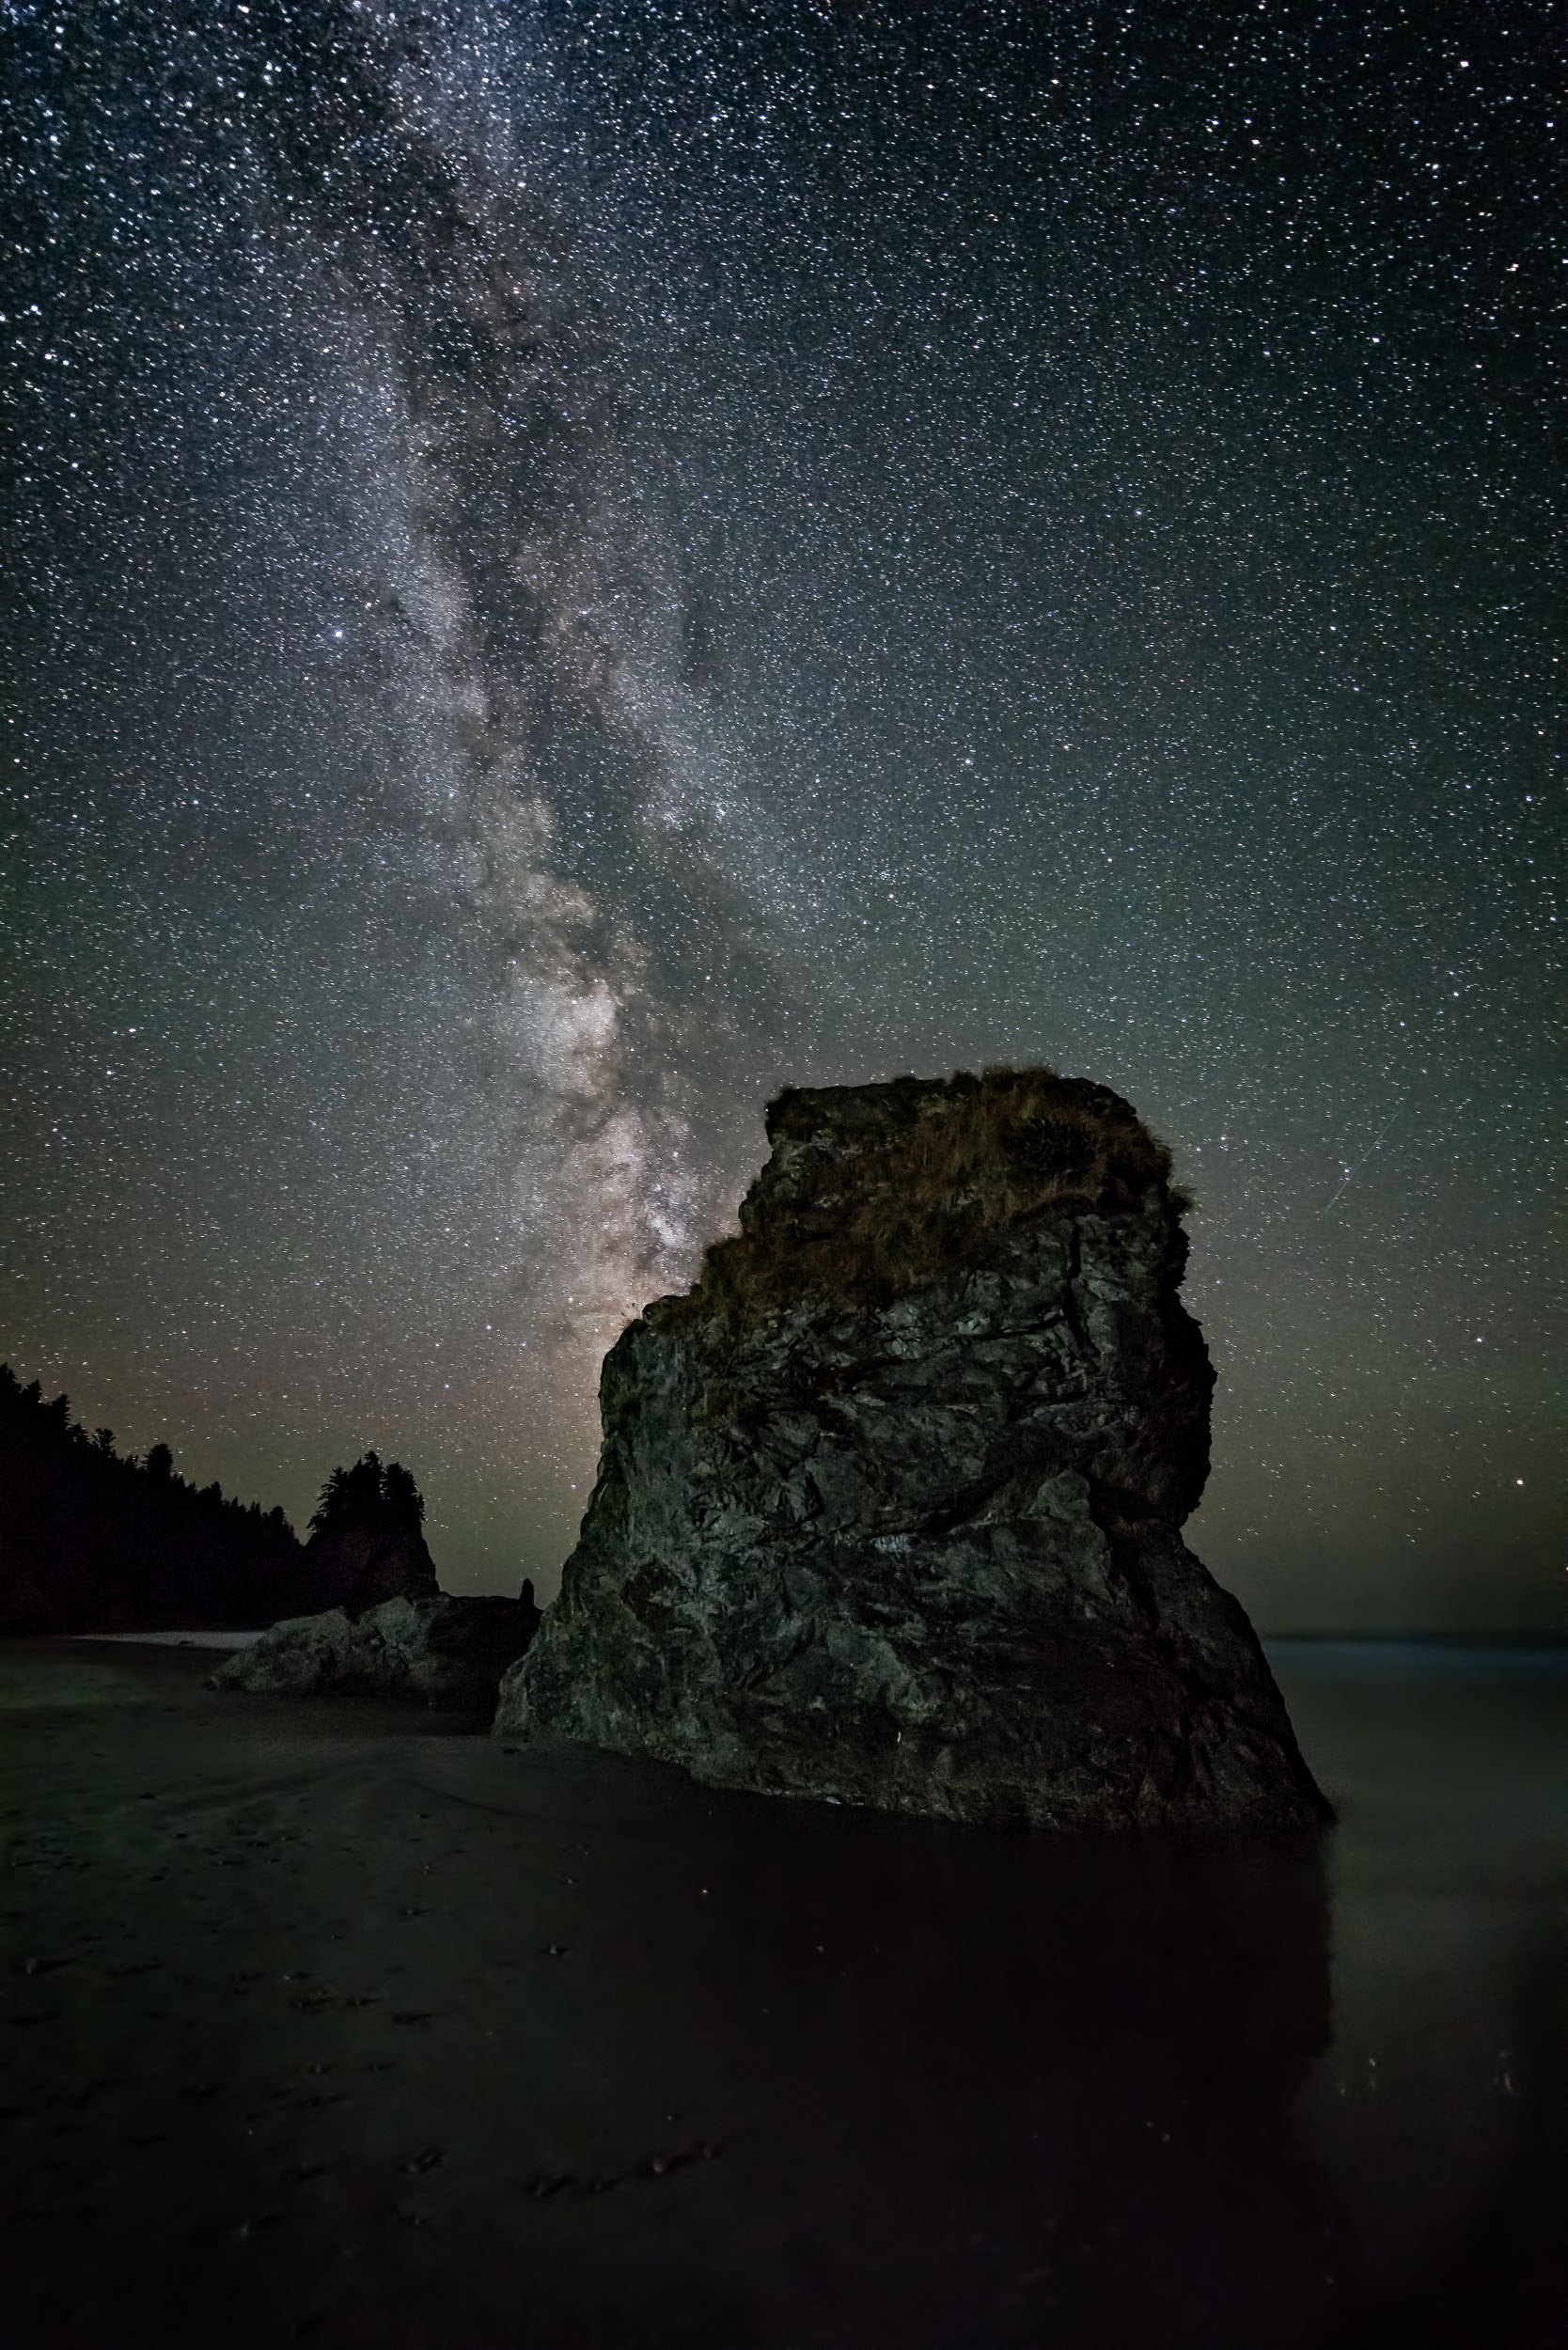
[1269,1640,1568,2345]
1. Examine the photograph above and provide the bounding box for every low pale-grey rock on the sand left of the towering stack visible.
[212,1584,539,1714]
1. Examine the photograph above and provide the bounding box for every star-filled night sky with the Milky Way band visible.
[0,0,1565,1629]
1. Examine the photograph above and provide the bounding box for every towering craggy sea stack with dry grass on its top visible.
[496,1070,1328,1828]
